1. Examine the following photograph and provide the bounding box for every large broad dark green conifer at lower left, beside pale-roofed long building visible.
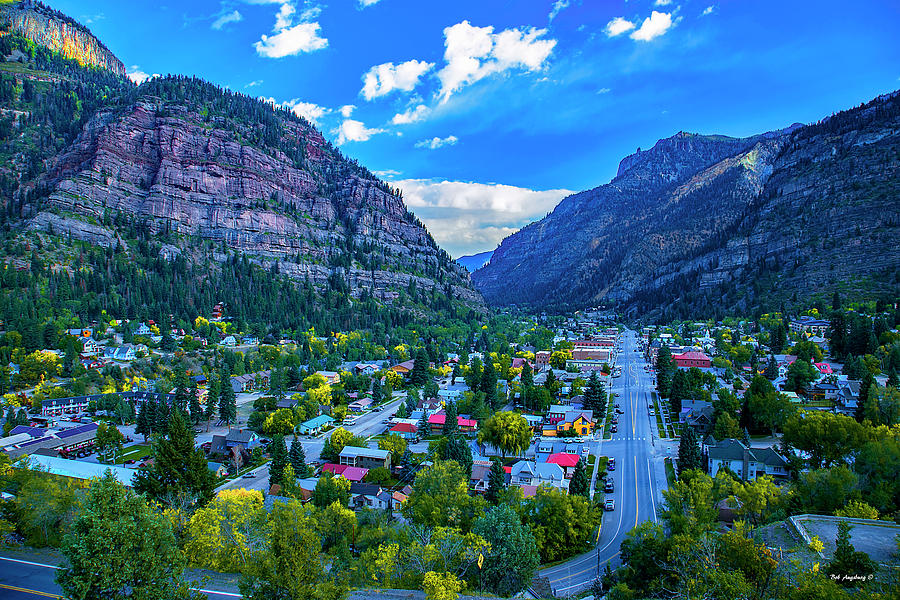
[134,410,216,506]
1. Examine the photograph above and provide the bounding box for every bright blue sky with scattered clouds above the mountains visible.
[56,0,900,256]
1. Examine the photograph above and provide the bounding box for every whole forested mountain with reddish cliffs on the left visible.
[0,4,484,328]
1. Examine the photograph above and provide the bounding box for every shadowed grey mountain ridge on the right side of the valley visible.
[473,93,900,318]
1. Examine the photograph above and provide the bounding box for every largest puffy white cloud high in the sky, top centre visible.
[437,21,556,102]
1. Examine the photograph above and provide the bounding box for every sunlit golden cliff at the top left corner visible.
[0,0,125,76]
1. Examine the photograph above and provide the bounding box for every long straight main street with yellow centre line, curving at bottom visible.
[540,330,669,596]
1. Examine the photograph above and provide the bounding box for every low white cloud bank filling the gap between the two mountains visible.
[391,179,572,256]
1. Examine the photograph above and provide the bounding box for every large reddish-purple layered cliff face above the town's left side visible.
[28,86,482,306]
